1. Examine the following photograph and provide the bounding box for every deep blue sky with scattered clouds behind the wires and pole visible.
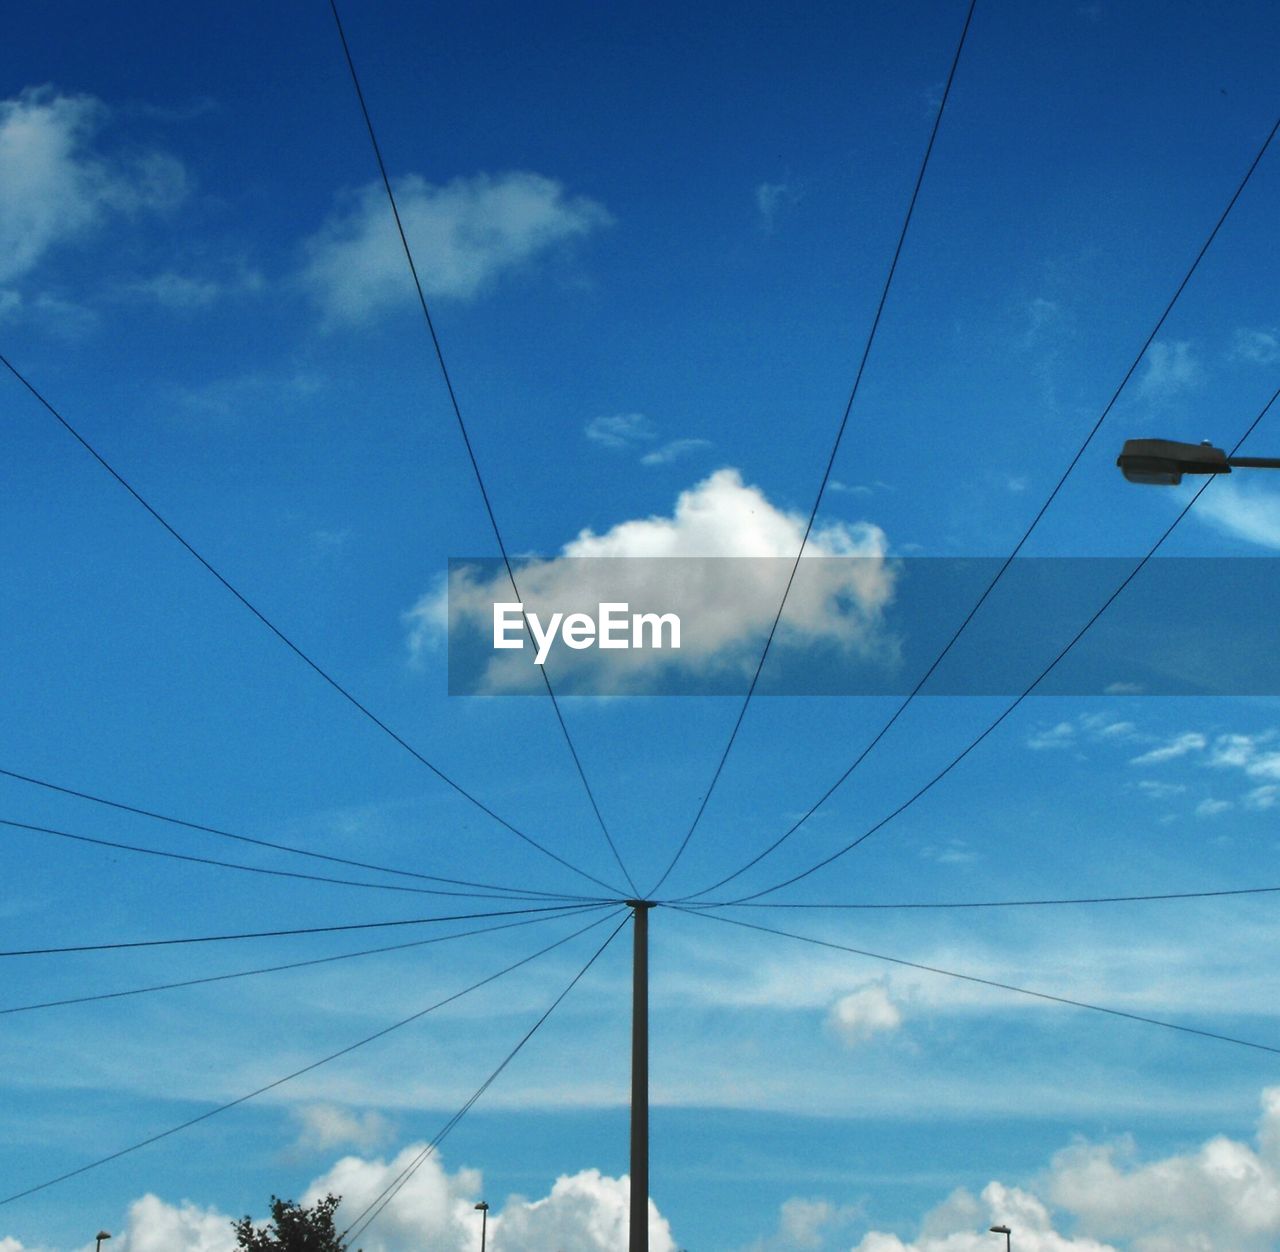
[0,0,1280,1252]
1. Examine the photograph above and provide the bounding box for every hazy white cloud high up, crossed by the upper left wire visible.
[303,172,612,321]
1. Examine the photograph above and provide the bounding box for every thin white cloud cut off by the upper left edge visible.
[0,87,187,283]
